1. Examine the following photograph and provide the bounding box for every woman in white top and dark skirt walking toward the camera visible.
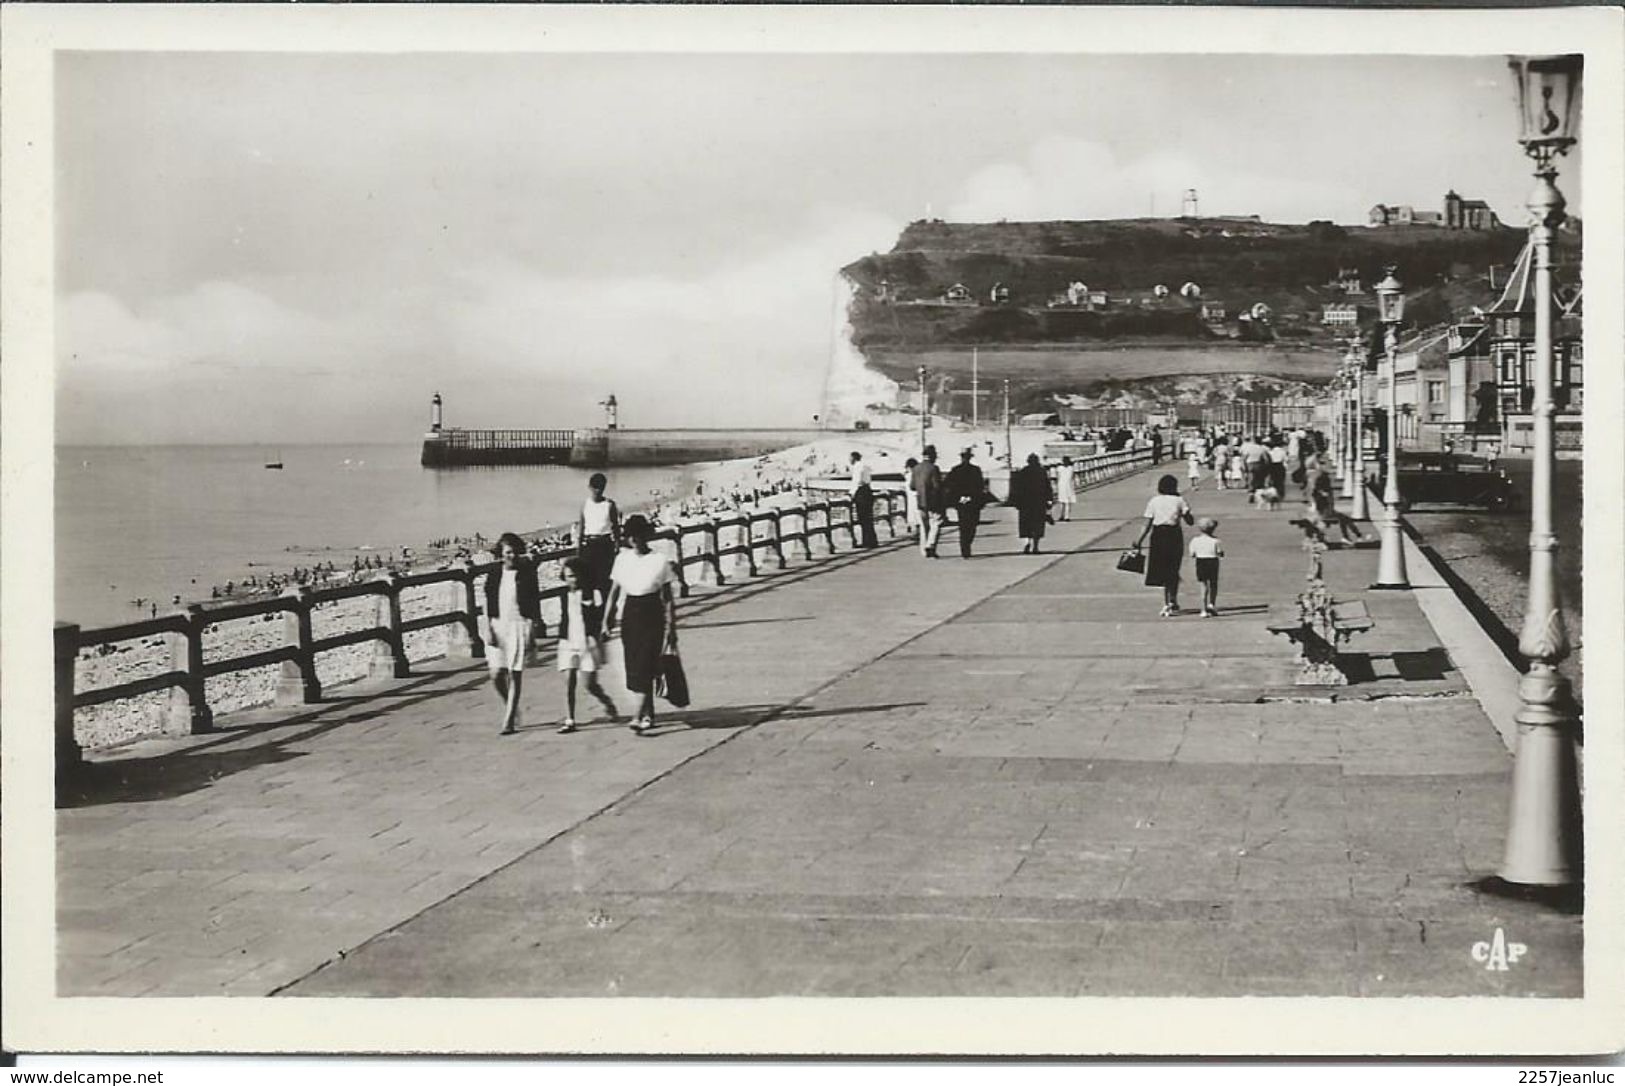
[605,514,678,735]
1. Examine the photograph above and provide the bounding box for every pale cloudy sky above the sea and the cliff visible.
[55,52,1580,444]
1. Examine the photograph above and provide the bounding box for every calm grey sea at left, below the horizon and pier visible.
[55,444,684,626]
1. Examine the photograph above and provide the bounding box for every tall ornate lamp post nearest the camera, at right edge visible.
[1502,55,1583,886]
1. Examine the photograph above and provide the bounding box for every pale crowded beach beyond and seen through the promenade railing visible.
[75,419,1079,749]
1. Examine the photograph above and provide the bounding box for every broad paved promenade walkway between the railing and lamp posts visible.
[59,461,1581,997]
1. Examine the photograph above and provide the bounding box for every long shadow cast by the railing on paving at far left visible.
[57,671,484,810]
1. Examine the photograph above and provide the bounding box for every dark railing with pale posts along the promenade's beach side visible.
[55,449,1151,769]
